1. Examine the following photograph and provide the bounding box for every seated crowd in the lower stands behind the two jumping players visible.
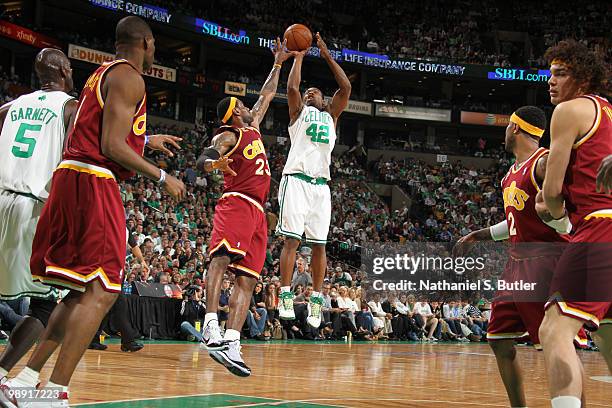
[111,118,520,341]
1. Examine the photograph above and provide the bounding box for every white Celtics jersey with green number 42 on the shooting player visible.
[283,105,336,180]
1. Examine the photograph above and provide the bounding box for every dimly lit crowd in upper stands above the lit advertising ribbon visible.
[145,0,612,67]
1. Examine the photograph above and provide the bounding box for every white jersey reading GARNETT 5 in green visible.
[0,91,73,200]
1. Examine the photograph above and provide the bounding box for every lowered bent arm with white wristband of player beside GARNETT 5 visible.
[101,64,185,200]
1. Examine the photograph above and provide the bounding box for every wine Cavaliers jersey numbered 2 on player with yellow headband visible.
[501,147,567,244]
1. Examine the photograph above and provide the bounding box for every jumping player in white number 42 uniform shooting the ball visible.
[276,33,351,328]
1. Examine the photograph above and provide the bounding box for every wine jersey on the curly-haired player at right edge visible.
[563,95,612,227]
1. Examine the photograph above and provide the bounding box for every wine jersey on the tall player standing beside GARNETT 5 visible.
[64,59,147,179]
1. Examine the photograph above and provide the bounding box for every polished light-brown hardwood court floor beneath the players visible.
[1,342,612,408]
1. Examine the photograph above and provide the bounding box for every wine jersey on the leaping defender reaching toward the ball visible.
[217,126,271,207]
